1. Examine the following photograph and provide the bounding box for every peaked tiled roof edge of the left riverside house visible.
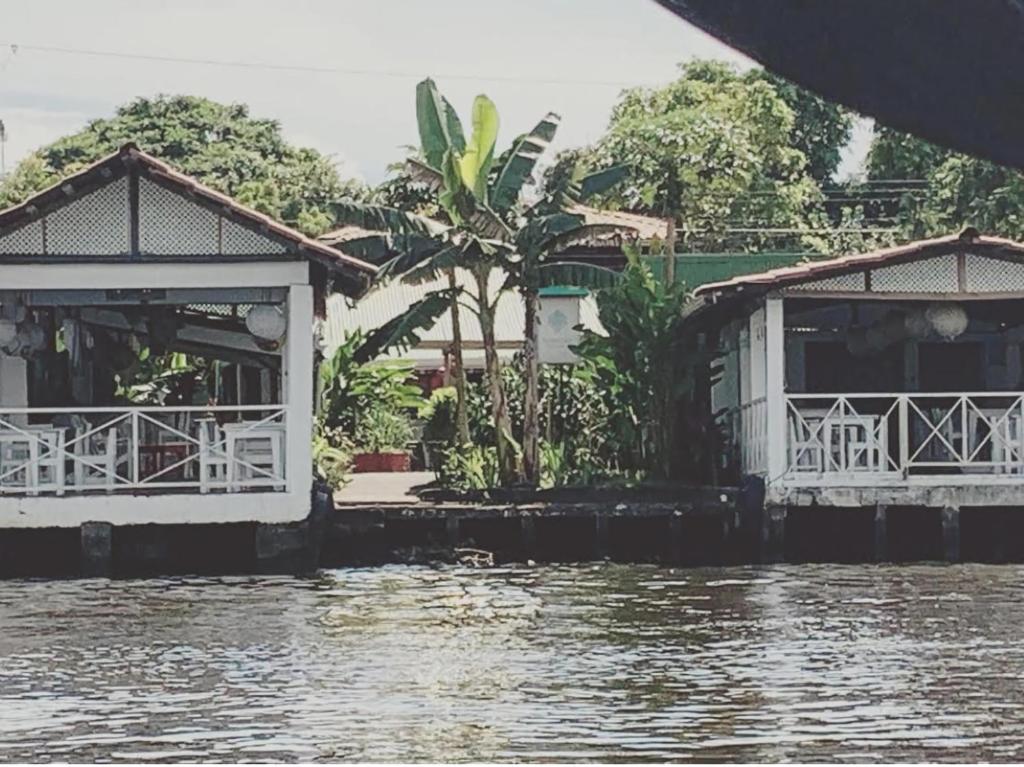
[0,143,377,294]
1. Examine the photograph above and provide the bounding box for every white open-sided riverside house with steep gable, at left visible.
[0,144,374,528]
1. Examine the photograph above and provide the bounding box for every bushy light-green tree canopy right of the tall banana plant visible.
[548,61,827,249]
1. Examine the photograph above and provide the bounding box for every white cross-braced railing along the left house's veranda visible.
[0,404,287,496]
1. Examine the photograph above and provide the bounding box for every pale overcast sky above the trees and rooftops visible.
[0,0,870,183]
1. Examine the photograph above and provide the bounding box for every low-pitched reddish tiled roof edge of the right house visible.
[694,228,1024,299]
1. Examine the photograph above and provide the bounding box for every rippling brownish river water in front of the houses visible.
[0,564,1024,761]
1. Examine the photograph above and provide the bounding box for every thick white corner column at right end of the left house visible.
[283,285,313,502]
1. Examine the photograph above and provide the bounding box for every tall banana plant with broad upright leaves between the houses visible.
[338,80,623,483]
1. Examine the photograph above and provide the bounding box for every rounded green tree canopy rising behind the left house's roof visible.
[0,95,364,235]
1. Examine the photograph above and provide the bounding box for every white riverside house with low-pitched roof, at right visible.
[689,229,1024,508]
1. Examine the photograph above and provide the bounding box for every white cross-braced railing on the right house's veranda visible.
[786,391,1024,479]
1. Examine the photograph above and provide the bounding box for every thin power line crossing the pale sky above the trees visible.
[0,41,650,88]
